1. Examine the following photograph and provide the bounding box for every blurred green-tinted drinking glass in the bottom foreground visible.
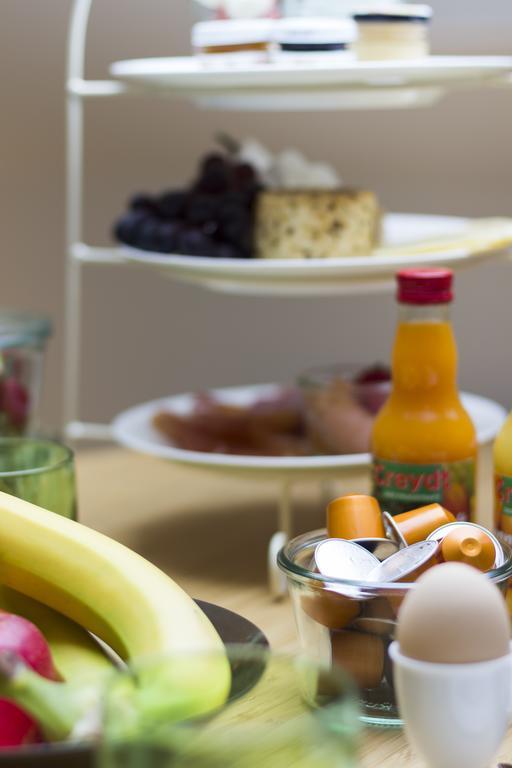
[98,646,358,768]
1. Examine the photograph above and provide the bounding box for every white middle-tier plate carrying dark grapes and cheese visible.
[122,213,512,296]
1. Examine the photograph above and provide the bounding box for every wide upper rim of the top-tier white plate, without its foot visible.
[110,56,512,96]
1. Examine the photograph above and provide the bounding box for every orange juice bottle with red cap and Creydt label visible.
[372,269,477,520]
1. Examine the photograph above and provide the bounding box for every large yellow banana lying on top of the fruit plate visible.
[0,493,231,708]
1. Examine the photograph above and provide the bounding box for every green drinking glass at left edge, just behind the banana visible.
[0,437,76,520]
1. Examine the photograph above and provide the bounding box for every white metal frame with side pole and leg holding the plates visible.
[64,0,292,598]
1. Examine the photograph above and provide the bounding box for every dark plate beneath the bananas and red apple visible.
[0,600,269,768]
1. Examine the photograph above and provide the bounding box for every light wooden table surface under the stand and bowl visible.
[77,448,512,768]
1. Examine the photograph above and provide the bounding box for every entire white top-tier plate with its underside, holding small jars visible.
[110,56,512,110]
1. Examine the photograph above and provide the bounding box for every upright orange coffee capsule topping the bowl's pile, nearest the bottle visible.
[327,495,384,540]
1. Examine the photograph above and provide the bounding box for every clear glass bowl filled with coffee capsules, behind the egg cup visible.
[278,530,512,726]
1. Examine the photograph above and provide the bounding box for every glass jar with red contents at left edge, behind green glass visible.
[0,311,51,437]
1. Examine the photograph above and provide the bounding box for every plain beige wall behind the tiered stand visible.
[0,0,512,432]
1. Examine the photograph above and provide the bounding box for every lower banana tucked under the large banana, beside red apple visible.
[0,587,114,683]
